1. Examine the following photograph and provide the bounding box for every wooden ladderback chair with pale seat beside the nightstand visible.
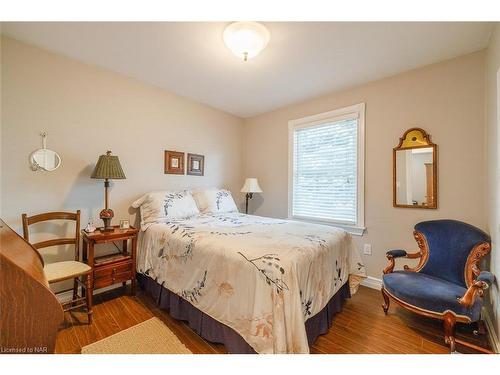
[22,210,92,324]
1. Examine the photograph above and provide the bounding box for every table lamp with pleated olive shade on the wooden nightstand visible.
[90,151,126,232]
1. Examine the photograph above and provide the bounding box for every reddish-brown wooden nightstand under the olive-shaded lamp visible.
[82,225,139,295]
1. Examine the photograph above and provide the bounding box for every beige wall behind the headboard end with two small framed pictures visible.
[1,38,243,242]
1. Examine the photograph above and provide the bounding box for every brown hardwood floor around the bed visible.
[56,287,489,354]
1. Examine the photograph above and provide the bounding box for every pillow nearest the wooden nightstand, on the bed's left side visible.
[132,191,200,226]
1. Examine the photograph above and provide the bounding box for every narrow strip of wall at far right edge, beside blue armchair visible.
[486,24,500,346]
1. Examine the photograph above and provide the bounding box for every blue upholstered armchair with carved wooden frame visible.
[382,220,494,352]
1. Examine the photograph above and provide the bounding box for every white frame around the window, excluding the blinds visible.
[288,103,366,236]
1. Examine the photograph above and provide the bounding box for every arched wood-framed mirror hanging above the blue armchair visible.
[393,128,438,209]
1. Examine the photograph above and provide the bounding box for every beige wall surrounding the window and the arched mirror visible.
[243,52,486,278]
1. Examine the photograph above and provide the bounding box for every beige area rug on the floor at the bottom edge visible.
[82,318,193,354]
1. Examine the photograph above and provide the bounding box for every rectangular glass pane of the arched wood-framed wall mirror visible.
[396,147,435,207]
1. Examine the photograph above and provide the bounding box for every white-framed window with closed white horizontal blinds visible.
[288,103,365,235]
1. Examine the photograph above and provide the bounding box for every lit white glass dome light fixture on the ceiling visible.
[222,22,271,61]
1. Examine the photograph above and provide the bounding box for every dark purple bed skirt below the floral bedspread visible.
[137,273,351,354]
